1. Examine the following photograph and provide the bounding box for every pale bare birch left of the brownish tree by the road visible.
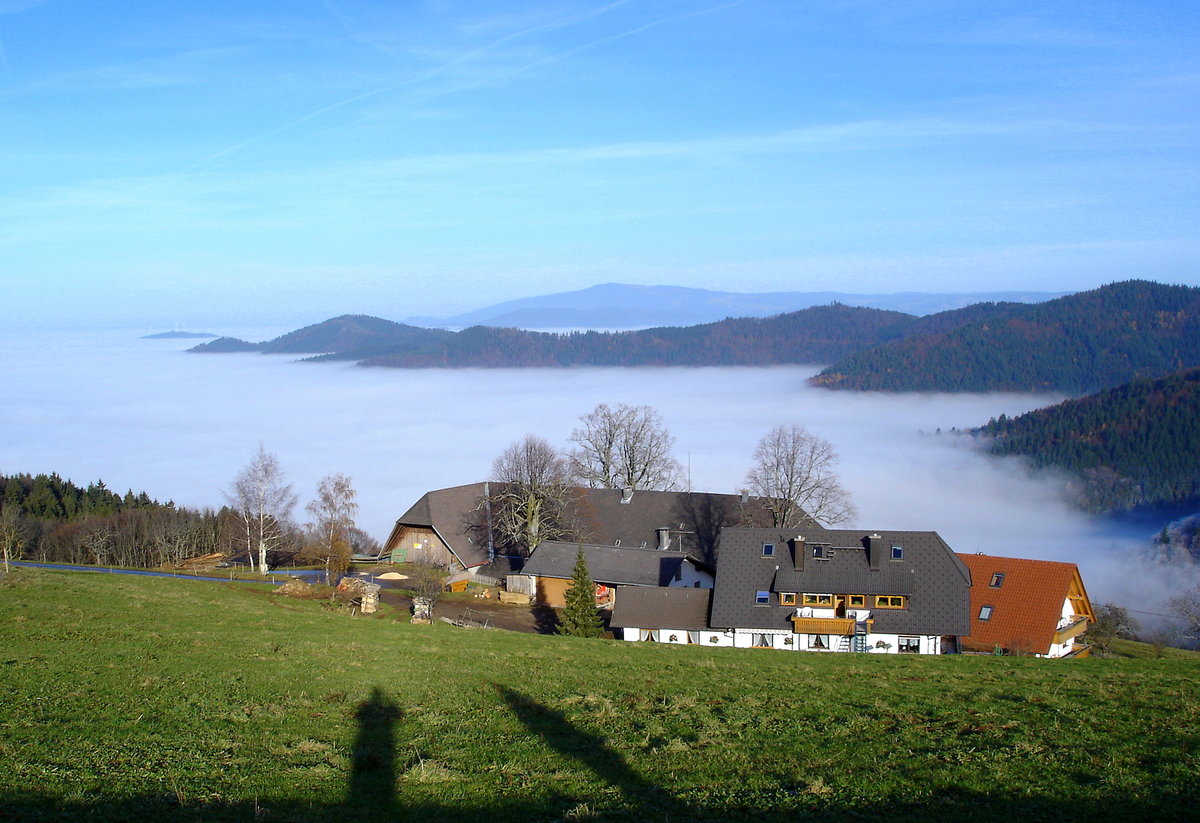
[227,445,296,573]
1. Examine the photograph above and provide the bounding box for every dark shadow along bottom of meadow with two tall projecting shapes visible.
[0,684,1200,823]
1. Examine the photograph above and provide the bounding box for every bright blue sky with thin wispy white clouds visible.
[0,0,1200,329]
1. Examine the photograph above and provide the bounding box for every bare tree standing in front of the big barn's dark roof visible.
[486,434,572,554]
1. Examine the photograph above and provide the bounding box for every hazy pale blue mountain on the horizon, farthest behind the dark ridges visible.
[404,283,1063,329]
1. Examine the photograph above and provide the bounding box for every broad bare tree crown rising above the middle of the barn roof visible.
[569,403,683,489]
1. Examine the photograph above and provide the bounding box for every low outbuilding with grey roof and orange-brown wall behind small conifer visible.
[518,541,713,607]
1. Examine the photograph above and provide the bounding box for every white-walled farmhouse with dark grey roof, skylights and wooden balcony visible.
[613,527,971,654]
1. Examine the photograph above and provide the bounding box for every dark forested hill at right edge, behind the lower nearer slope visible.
[811,281,1200,394]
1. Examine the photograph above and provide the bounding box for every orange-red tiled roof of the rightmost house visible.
[959,554,1094,654]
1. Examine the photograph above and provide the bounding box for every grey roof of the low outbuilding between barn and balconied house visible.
[521,540,702,585]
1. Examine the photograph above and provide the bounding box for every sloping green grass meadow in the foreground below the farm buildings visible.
[0,571,1200,823]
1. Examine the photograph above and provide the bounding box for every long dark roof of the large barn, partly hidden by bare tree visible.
[389,483,770,567]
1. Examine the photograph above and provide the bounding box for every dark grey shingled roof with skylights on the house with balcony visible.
[712,528,971,635]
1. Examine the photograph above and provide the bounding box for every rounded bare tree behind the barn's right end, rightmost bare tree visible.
[746,423,854,528]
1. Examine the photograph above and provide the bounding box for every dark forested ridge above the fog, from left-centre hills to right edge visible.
[191,281,1200,395]
